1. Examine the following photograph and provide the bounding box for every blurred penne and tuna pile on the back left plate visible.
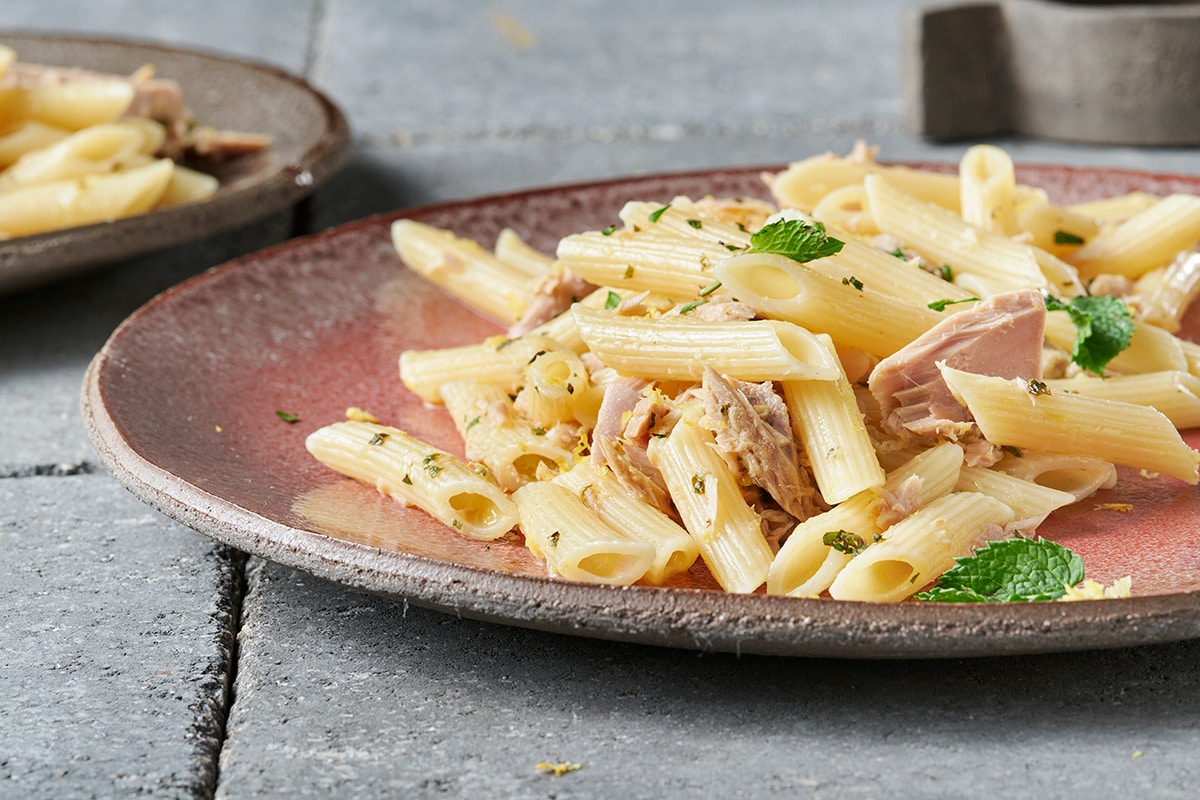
[0,46,268,239]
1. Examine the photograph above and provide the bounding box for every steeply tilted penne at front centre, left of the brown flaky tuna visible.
[647,419,773,593]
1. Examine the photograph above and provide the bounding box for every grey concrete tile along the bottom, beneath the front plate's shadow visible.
[217,561,1200,799]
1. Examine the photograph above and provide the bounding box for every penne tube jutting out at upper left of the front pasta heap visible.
[391,219,534,325]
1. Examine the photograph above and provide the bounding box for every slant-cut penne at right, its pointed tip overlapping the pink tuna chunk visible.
[942,366,1200,483]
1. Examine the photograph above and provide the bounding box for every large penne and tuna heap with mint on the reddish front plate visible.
[307,145,1200,601]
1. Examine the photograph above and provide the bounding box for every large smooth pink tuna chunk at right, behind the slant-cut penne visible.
[868,289,1045,440]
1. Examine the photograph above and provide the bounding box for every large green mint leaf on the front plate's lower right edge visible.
[917,536,1084,603]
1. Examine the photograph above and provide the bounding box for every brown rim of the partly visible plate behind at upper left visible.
[0,29,354,295]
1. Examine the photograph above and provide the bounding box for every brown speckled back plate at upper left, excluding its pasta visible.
[0,32,352,294]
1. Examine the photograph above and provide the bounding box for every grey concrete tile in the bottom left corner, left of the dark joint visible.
[0,475,241,799]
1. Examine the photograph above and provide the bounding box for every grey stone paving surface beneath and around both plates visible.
[7,0,1200,800]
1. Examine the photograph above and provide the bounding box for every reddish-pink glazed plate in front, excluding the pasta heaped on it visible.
[83,167,1200,658]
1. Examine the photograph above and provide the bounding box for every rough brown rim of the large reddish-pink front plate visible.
[80,162,1200,658]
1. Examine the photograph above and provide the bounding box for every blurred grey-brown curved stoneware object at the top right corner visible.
[902,0,1200,146]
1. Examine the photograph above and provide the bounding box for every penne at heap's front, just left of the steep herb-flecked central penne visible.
[554,458,700,583]
